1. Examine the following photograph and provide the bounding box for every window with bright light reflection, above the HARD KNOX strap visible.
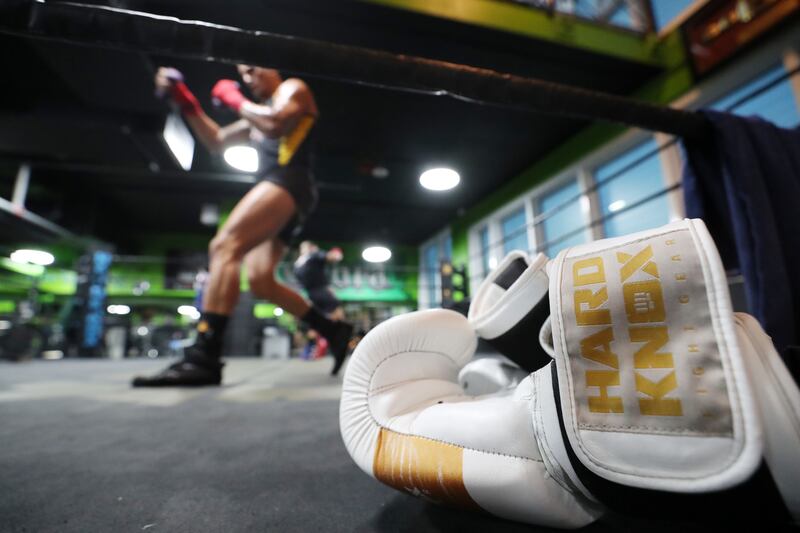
[594,140,669,237]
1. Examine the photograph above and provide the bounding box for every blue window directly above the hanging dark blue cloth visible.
[711,65,800,128]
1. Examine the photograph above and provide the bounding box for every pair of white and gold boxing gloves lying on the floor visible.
[340,220,800,528]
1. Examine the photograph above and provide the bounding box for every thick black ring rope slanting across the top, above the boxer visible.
[0,0,707,138]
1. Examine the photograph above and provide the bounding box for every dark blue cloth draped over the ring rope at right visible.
[683,111,800,380]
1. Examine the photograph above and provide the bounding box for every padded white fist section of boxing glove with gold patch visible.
[339,309,600,528]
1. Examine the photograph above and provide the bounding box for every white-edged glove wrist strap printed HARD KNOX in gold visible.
[549,220,763,494]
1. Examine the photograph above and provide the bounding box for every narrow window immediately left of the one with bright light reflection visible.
[539,180,586,257]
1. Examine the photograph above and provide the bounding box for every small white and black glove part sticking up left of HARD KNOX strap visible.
[468,251,550,372]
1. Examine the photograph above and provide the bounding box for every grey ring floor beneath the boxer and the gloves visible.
[0,358,724,533]
